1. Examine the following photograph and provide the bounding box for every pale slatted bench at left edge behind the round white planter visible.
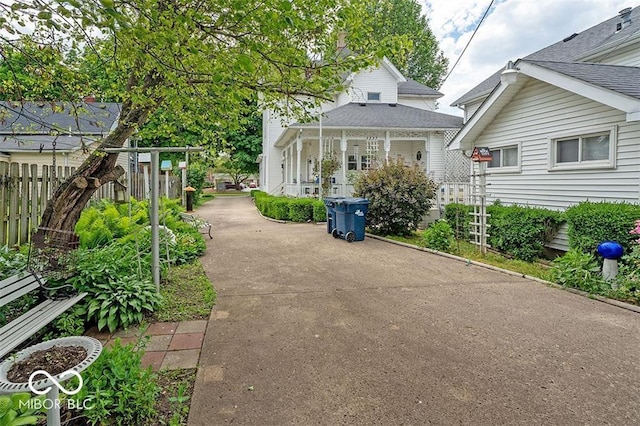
[0,272,87,358]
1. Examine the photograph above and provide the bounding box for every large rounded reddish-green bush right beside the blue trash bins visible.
[354,160,436,235]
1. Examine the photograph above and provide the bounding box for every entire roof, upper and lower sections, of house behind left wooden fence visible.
[0,102,121,152]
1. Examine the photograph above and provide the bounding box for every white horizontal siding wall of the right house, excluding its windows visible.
[475,81,640,210]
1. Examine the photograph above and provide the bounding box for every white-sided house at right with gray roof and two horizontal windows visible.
[448,7,640,250]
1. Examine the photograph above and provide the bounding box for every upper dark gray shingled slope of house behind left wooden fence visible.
[0,102,121,136]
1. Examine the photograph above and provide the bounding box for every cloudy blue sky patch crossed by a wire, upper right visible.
[419,0,640,116]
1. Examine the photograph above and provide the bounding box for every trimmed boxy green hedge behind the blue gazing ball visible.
[566,201,640,254]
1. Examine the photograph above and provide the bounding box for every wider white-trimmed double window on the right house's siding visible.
[549,128,616,170]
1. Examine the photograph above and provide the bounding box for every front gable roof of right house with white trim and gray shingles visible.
[449,60,640,149]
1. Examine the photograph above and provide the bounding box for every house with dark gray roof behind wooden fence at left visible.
[0,102,127,170]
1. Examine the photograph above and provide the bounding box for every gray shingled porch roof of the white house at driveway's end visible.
[290,103,462,129]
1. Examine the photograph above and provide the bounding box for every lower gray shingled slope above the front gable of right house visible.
[523,61,640,99]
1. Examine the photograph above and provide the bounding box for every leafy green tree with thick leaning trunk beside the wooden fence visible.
[0,0,394,230]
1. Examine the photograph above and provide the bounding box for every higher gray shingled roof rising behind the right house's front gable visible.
[451,6,640,106]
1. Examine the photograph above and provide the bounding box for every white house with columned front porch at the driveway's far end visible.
[258,59,468,200]
